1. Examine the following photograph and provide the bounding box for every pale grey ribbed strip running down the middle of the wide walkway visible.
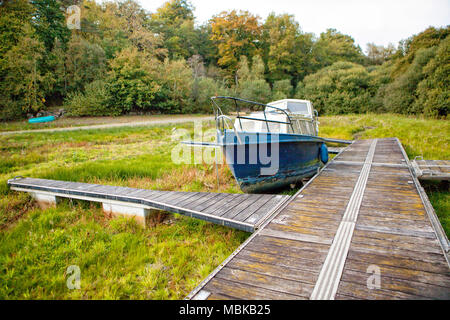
[310,139,377,300]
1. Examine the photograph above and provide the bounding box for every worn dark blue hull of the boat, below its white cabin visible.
[221,130,324,193]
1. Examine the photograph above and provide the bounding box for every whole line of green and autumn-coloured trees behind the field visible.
[0,0,450,120]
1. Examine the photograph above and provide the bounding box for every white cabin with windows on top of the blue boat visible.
[234,99,319,136]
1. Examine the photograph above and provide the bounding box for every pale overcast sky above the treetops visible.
[137,0,450,50]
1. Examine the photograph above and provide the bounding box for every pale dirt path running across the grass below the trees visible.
[0,116,214,135]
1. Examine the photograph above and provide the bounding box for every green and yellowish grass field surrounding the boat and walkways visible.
[0,115,450,299]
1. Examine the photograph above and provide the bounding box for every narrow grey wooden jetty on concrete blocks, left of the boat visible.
[8,178,289,232]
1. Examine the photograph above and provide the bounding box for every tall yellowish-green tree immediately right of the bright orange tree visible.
[263,13,313,82]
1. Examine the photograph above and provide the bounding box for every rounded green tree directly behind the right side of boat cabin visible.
[296,62,370,114]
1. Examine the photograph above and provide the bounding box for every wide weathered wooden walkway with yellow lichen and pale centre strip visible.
[187,138,450,299]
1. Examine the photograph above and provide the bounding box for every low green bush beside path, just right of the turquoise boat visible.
[65,80,114,116]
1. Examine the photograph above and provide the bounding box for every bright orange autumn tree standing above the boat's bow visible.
[211,10,262,77]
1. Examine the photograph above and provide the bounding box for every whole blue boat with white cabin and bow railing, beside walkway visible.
[211,97,328,193]
